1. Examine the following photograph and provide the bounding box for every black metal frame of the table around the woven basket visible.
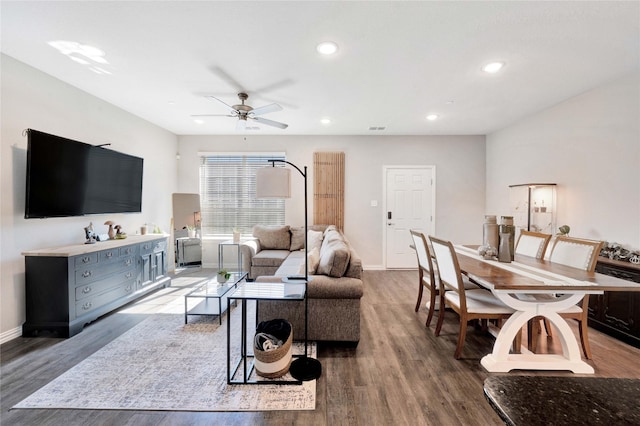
[227,292,306,385]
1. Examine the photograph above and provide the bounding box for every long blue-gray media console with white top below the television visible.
[22,234,171,337]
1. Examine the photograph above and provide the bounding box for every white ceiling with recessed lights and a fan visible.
[1,0,640,135]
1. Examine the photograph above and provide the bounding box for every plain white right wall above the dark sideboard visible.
[487,73,640,249]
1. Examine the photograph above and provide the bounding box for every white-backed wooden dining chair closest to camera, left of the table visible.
[429,236,520,359]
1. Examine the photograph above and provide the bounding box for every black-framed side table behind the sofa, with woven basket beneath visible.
[227,282,306,385]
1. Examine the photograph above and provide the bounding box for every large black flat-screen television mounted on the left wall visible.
[24,129,143,219]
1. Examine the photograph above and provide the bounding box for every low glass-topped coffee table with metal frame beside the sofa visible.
[184,272,247,325]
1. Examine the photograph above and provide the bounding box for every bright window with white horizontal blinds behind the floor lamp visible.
[200,153,285,235]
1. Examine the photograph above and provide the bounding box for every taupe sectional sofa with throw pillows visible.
[241,225,364,346]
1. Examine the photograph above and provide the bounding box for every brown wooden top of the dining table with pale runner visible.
[457,246,640,293]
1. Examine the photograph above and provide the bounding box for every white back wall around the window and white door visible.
[178,136,485,269]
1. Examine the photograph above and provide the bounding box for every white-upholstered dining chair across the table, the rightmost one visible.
[549,236,604,359]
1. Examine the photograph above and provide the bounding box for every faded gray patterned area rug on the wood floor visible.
[13,302,316,411]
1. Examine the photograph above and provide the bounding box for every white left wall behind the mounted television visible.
[0,55,177,340]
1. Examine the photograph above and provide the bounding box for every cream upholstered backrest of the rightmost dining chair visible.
[549,236,604,272]
